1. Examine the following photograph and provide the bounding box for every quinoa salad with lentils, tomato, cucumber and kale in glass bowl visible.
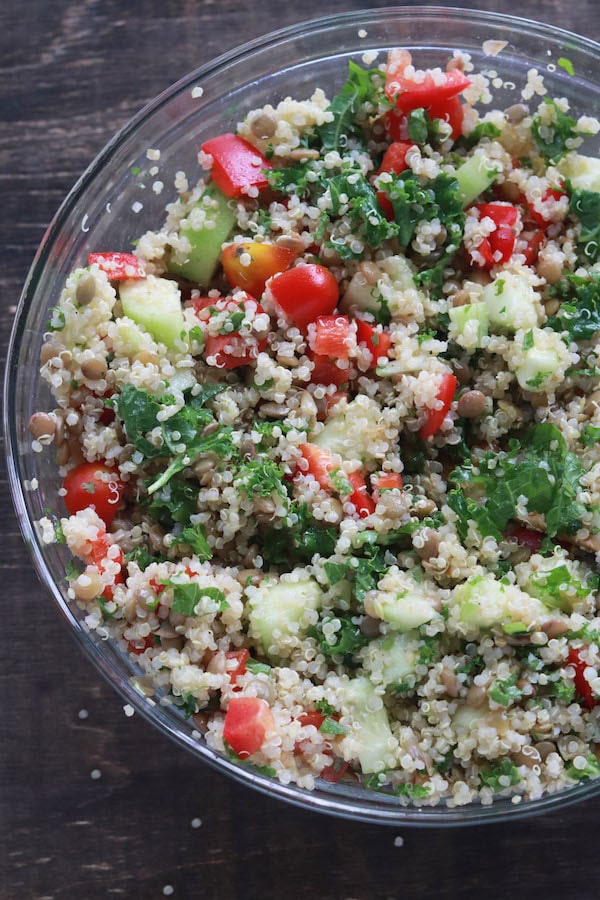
[29,50,600,807]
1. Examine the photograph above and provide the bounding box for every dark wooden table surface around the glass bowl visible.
[0,0,600,900]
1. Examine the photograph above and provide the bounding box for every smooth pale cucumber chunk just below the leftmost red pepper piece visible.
[119,275,185,350]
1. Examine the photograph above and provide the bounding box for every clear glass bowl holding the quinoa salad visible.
[4,7,600,826]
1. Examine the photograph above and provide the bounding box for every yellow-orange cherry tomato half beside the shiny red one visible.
[221,241,296,297]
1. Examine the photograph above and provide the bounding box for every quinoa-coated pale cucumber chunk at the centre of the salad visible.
[313,394,385,462]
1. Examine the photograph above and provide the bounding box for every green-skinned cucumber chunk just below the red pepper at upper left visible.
[168,184,236,287]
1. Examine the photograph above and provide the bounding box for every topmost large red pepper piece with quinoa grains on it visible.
[385,50,471,113]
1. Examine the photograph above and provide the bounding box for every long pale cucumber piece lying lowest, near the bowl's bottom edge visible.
[343,677,396,775]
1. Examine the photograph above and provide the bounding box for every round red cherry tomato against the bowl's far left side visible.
[63,462,125,526]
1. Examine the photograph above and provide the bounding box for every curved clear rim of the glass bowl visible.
[3,6,600,827]
